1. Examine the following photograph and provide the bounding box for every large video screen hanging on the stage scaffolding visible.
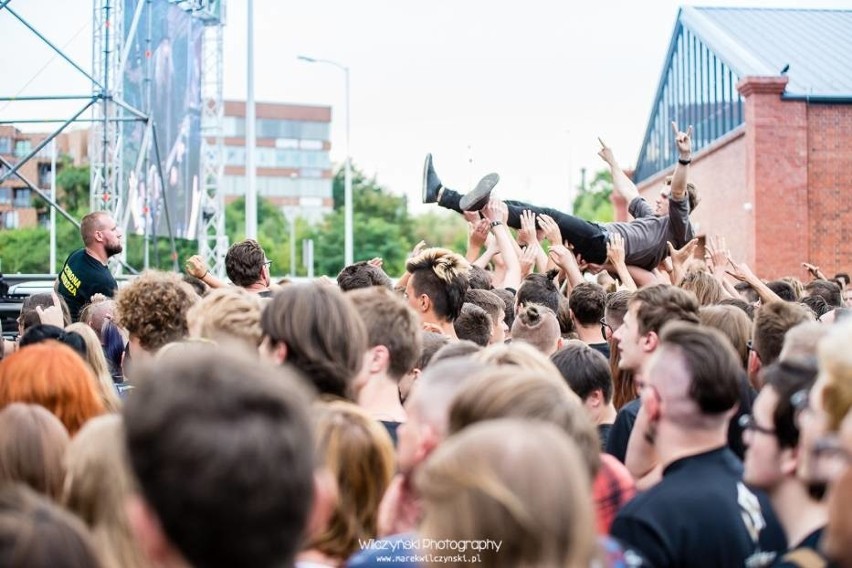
[123,0,203,239]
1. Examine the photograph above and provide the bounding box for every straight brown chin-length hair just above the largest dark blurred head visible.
[260,283,367,398]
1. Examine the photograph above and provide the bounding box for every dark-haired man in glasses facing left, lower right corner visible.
[740,361,828,566]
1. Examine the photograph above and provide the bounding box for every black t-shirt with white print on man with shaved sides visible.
[610,447,786,568]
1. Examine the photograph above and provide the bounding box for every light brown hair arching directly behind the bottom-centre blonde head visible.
[449,367,601,479]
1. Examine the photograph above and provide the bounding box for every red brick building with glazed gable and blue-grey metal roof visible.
[616,7,852,278]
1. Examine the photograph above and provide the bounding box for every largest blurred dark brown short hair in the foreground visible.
[124,345,314,568]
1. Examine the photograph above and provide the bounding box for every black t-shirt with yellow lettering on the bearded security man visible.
[58,249,118,321]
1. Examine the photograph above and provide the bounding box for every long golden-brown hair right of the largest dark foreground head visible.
[306,400,395,560]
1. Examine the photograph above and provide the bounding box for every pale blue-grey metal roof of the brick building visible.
[680,7,852,98]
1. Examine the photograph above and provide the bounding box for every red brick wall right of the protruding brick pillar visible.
[807,104,852,277]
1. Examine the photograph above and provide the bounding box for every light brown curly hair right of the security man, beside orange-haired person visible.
[115,270,198,352]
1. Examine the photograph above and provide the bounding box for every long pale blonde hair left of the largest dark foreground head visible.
[62,414,147,568]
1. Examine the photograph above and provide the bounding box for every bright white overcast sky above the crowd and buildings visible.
[0,0,852,211]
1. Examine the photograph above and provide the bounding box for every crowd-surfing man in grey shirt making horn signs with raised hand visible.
[423,122,699,273]
